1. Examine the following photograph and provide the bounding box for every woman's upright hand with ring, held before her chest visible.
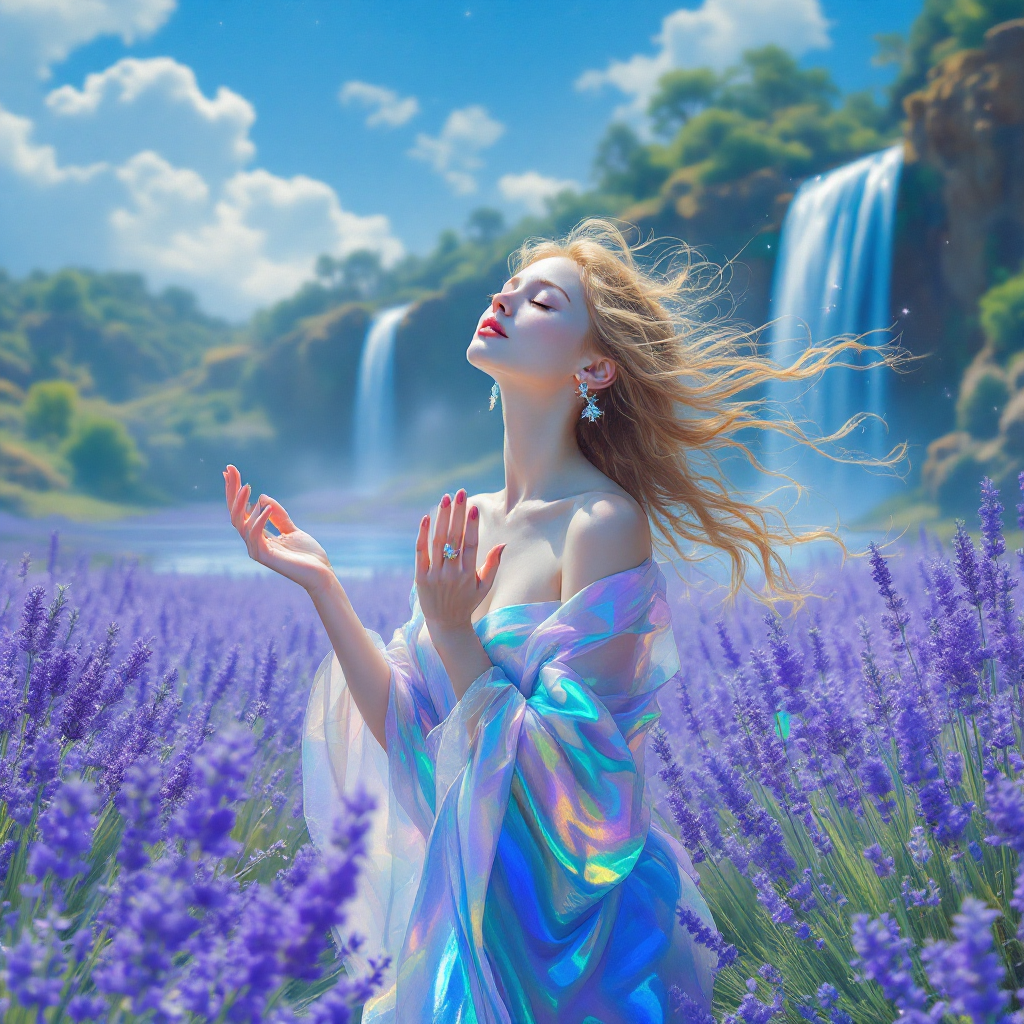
[416,489,505,632]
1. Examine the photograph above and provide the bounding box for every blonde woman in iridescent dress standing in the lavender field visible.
[224,220,897,1024]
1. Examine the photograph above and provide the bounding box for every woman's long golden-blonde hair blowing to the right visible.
[509,218,906,604]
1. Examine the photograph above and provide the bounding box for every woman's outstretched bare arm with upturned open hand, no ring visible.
[224,466,391,750]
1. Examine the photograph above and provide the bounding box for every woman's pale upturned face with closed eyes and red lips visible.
[466,256,590,386]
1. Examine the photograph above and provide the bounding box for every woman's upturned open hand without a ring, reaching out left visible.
[224,466,334,591]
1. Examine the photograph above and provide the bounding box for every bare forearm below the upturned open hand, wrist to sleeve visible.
[307,571,391,750]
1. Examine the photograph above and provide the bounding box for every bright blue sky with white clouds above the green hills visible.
[0,0,921,317]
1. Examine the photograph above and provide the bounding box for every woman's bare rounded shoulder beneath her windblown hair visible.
[562,488,651,601]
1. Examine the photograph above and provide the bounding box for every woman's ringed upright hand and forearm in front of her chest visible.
[416,489,505,700]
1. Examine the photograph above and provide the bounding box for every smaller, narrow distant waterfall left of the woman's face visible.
[353,305,409,492]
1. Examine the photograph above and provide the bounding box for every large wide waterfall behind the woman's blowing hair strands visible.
[765,144,903,522]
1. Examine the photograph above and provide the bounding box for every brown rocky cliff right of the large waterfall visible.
[904,19,1024,513]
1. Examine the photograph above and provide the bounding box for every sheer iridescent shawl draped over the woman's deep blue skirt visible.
[302,558,714,1024]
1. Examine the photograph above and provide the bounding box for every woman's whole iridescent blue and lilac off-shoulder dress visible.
[302,558,714,1024]
